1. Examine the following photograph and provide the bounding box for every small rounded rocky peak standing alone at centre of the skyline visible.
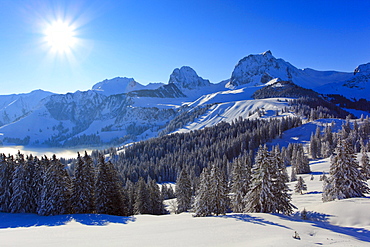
[168,66,211,89]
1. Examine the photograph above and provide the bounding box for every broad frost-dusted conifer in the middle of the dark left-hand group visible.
[37,155,71,216]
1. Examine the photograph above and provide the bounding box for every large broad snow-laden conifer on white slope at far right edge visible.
[322,140,369,202]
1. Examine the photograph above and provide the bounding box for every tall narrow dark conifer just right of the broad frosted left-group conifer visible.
[71,152,95,214]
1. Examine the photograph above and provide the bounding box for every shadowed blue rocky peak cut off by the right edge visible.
[343,63,370,90]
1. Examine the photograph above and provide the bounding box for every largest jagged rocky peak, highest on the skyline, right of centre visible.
[228,51,302,87]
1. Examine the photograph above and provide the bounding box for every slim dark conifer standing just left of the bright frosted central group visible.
[176,169,193,213]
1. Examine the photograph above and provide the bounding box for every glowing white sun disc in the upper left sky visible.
[44,20,77,53]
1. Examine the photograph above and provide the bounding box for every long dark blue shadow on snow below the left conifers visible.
[0,213,135,229]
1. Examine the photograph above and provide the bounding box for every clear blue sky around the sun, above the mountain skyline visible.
[0,0,370,94]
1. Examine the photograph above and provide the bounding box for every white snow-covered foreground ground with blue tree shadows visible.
[0,154,370,247]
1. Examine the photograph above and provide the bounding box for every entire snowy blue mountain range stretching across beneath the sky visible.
[0,51,370,147]
